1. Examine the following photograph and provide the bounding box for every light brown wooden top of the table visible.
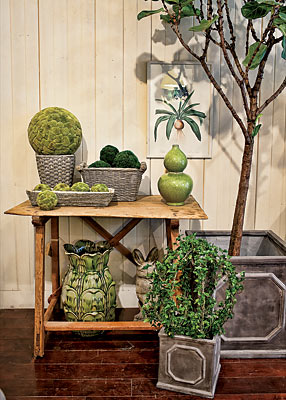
[5,195,208,219]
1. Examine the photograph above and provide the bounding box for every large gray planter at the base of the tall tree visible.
[186,231,286,358]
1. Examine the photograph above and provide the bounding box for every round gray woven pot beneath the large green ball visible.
[36,154,75,188]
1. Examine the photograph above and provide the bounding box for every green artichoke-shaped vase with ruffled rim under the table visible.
[62,240,116,336]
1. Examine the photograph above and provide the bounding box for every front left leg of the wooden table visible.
[32,217,48,357]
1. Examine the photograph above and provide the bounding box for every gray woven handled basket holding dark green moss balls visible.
[76,162,147,201]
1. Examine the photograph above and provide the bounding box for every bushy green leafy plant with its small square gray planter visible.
[143,235,244,398]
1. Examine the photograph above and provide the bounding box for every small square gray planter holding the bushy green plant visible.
[157,329,220,398]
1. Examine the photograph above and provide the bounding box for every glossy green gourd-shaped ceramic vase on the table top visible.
[158,144,193,206]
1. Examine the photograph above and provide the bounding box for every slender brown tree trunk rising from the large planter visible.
[228,139,254,256]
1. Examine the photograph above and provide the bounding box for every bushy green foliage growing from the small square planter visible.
[143,235,244,339]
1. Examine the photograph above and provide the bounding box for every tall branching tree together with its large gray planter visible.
[138,0,286,357]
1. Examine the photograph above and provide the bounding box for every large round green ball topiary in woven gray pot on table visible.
[28,107,82,188]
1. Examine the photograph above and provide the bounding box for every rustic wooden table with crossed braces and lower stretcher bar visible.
[5,196,207,357]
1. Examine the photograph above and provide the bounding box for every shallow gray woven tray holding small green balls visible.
[26,188,114,207]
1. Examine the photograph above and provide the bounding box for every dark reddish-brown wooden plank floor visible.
[0,310,286,400]
